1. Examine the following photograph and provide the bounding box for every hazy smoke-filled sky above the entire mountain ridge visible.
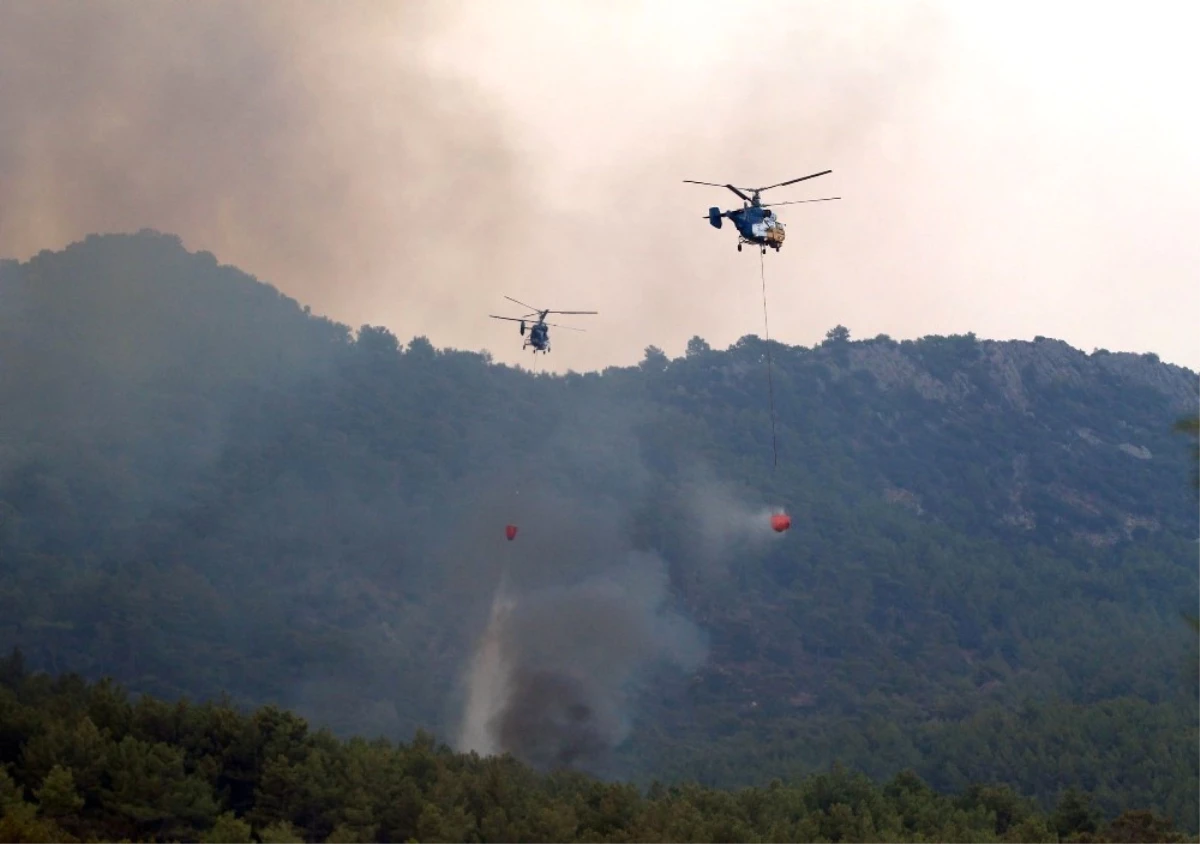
[0,0,1200,370]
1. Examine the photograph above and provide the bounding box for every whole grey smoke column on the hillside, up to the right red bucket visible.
[451,451,780,773]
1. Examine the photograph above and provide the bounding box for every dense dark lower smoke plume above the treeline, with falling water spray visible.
[458,552,706,771]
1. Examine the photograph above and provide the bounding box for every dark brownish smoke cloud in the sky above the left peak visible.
[0,0,522,340]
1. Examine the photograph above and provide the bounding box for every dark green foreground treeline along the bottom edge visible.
[0,653,1196,844]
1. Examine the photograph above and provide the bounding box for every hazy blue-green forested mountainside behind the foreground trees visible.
[0,232,1200,840]
